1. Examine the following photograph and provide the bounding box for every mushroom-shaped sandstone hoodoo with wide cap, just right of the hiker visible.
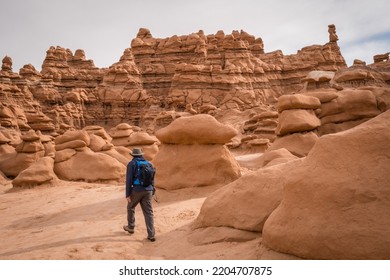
[154,114,240,189]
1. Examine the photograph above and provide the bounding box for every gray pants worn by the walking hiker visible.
[127,191,154,238]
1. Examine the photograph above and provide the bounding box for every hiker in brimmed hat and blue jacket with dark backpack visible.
[123,148,156,242]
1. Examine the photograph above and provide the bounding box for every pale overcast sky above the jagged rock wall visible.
[0,0,390,72]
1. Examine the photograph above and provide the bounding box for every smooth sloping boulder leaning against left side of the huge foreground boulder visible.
[193,160,301,232]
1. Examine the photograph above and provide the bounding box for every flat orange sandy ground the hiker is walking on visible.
[0,164,298,260]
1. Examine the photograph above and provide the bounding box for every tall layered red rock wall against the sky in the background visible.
[0,25,346,133]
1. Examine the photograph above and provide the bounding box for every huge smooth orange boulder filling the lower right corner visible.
[263,111,390,259]
